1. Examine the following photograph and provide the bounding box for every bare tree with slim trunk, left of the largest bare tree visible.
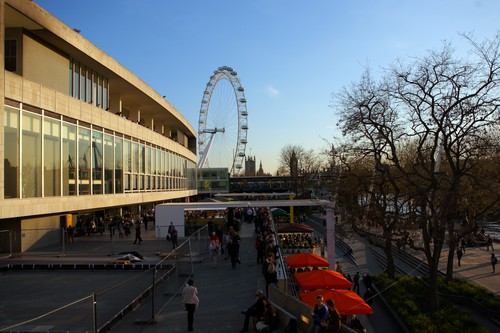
[332,70,404,277]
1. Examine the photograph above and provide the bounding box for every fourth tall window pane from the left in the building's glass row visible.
[62,123,78,195]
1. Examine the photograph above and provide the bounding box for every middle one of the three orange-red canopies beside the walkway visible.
[293,269,352,290]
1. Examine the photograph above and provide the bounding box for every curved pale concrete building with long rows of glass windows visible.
[0,0,197,253]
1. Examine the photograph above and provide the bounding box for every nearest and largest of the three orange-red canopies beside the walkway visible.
[299,289,373,316]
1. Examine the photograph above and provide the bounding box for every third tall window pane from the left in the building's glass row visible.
[43,118,61,197]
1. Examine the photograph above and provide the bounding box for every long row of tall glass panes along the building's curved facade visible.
[4,106,195,199]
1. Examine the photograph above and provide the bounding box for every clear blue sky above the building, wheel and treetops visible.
[35,0,500,174]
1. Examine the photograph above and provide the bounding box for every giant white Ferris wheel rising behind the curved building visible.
[198,66,248,175]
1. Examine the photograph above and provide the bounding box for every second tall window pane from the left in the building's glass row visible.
[21,112,42,198]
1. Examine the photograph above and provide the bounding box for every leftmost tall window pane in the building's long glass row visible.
[3,107,20,199]
